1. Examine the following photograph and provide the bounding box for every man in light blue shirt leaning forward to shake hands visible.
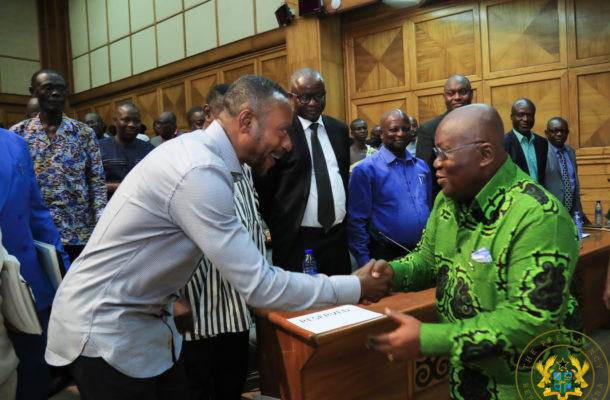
[46,75,389,399]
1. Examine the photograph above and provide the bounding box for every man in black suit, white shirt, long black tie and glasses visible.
[254,68,351,275]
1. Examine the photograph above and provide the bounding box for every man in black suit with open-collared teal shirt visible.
[504,99,549,186]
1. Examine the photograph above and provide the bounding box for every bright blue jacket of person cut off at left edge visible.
[0,129,70,310]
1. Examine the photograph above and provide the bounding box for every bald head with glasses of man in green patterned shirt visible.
[434,104,507,202]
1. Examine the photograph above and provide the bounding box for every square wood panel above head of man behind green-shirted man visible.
[409,5,481,89]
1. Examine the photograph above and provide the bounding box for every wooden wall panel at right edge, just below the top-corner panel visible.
[574,68,610,148]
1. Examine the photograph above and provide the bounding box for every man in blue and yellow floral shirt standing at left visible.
[11,70,106,260]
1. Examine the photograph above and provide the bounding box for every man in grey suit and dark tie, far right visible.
[544,117,590,224]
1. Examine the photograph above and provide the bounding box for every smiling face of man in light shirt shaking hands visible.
[240,99,292,174]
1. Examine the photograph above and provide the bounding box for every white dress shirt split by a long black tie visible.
[299,115,346,228]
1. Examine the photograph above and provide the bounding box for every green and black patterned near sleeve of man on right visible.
[420,213,578,363]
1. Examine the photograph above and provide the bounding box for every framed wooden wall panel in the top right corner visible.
[567,0,610,66]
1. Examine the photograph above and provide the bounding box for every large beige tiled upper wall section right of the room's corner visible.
[69,0,282,93]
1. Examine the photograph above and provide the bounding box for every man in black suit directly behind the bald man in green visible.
[415,75,472,197]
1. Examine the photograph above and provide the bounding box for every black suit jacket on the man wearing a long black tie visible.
[254,114,349,256]
